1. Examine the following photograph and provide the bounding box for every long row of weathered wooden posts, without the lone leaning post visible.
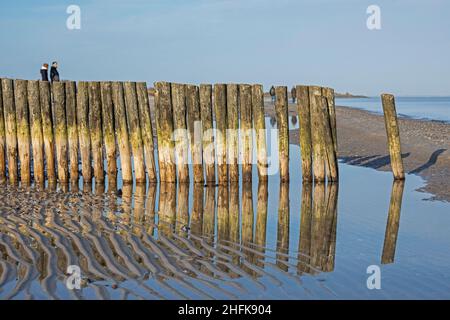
[0,79,401,184]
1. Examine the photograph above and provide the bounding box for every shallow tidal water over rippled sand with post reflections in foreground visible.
[0,119,450,299]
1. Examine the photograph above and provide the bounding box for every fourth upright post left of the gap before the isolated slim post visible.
[214,84,228,184]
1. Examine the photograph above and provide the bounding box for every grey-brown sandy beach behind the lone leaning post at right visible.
[266,104,450,202]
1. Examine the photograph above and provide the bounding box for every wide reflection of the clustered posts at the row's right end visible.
[310,184,338,272]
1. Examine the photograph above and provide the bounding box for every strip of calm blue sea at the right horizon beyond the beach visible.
[336,97,450,122]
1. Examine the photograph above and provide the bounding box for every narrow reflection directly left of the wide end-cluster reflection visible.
[297,181,313,274]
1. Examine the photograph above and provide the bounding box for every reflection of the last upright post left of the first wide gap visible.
[255,180,269,266]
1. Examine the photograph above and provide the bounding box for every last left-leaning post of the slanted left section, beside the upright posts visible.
[136,82,157,183]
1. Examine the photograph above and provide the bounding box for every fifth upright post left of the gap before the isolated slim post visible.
[200,84,216,185]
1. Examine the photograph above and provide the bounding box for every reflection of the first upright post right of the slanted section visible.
[158,183,176,234]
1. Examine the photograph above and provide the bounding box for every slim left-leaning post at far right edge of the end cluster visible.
[316,96,339,182]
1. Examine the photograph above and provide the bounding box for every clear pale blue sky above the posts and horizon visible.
[0,0,450,95]
